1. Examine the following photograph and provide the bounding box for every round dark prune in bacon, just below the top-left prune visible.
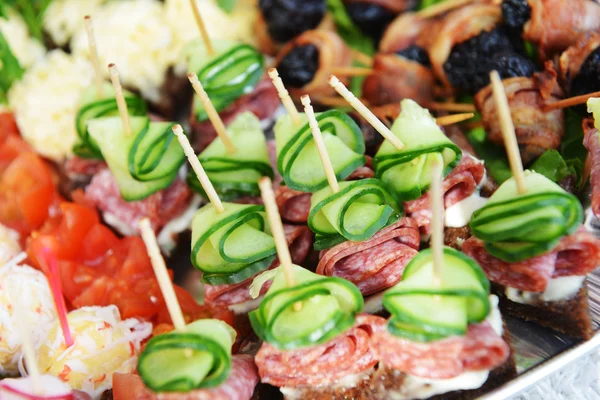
[277,44,319,88]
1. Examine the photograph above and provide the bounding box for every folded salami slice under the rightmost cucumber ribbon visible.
[463,228,600,292]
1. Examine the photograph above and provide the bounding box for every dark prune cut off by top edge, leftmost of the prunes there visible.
[258,0,327,43]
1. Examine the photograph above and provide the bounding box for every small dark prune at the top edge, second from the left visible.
[346,2,396,42]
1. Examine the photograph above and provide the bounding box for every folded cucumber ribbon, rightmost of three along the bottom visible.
[383,247,490,342]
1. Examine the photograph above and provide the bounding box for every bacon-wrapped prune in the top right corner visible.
[502,0,600,59]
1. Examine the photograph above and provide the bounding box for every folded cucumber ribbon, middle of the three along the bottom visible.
[248,265,364,350]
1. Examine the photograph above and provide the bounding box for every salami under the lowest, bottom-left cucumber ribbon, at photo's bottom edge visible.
[113,354,258,400]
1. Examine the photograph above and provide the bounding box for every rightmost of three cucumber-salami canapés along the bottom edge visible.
[372,247,516,399]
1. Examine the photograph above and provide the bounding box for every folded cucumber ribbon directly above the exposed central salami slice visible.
[308,178,402,250]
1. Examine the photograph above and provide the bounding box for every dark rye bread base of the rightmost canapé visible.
[492,283,594,339]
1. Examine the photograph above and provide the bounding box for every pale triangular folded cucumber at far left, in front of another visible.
[88,117,185,201]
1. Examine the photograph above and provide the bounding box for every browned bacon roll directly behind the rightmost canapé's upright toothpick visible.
[475,64,565,164]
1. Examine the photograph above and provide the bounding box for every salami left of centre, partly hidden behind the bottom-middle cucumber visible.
[204,225,312,306]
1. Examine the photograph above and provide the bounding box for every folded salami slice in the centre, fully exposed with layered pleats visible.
[316,218,420,296]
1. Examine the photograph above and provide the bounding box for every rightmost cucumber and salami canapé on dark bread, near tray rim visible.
[463,171,600,338]
